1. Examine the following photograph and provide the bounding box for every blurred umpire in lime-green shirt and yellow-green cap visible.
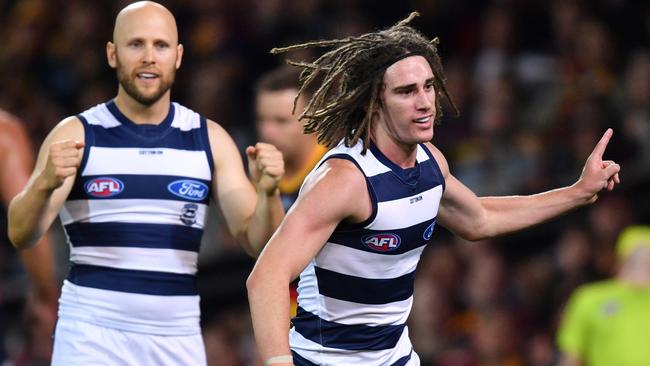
[557,226,650,366]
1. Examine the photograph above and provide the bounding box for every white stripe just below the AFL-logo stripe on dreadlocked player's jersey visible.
[316,242,425,279]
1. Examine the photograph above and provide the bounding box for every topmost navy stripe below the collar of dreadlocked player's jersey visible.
[368,169,442,202]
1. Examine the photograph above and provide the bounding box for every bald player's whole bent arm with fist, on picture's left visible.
[8,117,84,249]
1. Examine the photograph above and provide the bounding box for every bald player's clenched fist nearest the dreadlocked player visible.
[246,142,284,194]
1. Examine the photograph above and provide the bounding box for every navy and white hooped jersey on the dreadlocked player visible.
[289,139,444,366]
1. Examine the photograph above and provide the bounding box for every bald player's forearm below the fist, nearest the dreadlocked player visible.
[246,189,284,257]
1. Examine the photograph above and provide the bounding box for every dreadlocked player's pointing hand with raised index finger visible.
[576,128,621,203]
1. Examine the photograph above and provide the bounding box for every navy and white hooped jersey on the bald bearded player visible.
[59,101,213,335]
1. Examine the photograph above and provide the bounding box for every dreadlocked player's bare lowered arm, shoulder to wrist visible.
[246,159,372,366]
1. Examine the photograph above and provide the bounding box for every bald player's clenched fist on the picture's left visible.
[41,140,86,190]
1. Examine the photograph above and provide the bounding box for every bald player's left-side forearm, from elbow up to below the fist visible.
[8,178,52,249]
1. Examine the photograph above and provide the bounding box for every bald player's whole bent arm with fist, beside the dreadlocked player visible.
[208,121,284,257]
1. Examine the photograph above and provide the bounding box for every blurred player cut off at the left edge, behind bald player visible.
[0,109,59,365]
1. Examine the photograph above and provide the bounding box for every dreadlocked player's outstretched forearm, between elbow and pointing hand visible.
[478,186,589,239]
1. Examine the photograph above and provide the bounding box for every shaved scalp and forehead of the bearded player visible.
[113,1,178,45]
